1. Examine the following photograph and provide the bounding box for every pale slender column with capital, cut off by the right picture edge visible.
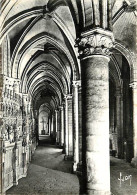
[130,81,137,168]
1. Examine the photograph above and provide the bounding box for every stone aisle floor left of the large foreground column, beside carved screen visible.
[7,140,79,195]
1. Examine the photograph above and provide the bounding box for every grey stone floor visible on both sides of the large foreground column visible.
[7,144,137,195]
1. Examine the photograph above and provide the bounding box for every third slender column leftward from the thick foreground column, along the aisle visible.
[60,106,64,146]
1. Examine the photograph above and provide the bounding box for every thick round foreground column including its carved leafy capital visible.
[77,29,113,195]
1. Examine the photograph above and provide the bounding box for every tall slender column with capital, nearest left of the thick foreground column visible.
[73,81,81,172]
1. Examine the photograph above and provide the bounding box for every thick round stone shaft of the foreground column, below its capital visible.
[81,55,110,195]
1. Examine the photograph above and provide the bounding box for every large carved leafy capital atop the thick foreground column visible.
[75,28,114,58]
